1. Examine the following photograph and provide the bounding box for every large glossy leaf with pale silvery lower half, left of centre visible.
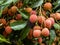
[10,21,27,30]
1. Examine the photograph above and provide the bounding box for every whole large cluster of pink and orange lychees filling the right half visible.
[27,2,60,44]
